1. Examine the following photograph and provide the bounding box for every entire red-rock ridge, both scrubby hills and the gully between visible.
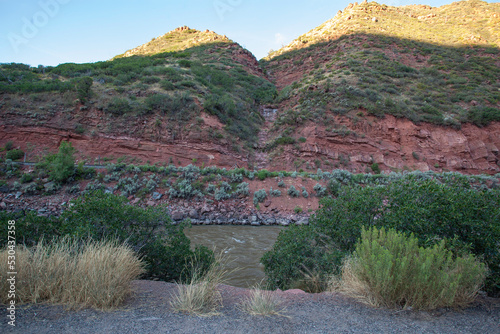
[0,0,500,174]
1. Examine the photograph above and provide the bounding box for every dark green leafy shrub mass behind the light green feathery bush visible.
[311,178,500,295]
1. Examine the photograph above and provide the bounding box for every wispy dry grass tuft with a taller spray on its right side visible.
[170,252,229,317]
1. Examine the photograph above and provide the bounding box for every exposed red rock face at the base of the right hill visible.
[271,116,500,174]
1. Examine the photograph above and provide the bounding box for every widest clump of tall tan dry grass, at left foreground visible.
[0,238,144,309]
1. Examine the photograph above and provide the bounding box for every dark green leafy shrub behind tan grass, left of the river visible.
[61,192,213,281]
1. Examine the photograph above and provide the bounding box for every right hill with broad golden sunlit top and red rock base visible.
[261,1,500,173]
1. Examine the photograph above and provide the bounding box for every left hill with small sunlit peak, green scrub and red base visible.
[0,27,276,167]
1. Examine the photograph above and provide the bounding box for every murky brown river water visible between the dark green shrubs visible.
[184,225,284,288]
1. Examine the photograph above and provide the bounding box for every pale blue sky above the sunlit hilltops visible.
[0,0,494,66]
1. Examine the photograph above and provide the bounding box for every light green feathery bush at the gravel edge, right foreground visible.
[340,227,487,309]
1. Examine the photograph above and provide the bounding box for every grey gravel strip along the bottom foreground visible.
[0,281,500,334]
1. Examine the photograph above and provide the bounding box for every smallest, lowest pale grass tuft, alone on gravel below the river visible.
[239,285,286,317]
